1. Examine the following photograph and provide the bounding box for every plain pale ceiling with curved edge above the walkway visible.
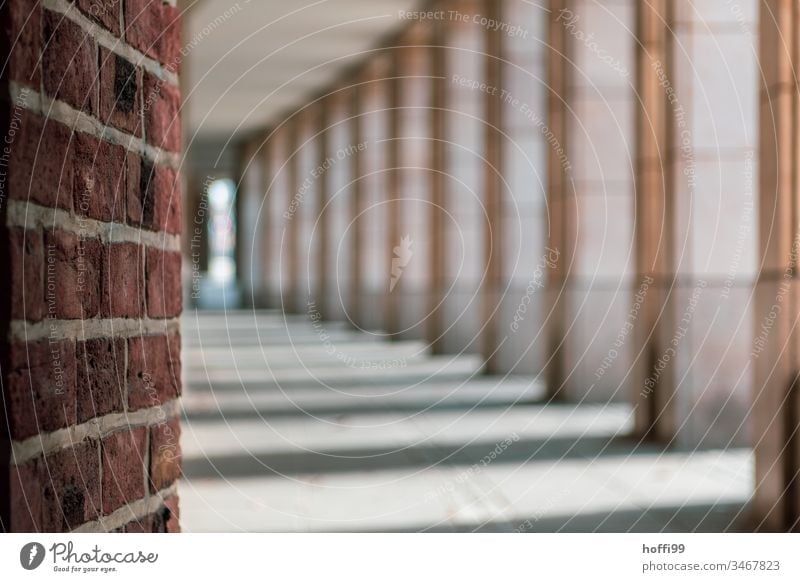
[179,0,416,141]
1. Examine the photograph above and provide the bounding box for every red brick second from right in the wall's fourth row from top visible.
[101,243,144,317]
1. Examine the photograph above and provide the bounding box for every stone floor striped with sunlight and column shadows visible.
[180,311,753,532]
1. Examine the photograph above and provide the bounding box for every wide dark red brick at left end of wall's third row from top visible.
[8,110,72,210]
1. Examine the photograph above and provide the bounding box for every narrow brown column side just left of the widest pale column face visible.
[631,0,676,442]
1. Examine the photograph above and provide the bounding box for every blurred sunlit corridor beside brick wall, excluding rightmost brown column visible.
[173,0,780,531]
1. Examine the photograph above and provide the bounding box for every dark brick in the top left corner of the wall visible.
[0,2,42,90]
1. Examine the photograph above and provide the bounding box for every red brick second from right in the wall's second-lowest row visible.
[102,427,147,514]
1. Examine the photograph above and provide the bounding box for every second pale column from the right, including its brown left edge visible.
[549,0,636,402]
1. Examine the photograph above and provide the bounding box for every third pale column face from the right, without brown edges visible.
[498,0,559,375]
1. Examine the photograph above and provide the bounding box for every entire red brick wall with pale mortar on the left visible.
[0,0,182,532]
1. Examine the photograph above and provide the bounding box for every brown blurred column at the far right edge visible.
[752,0,800,531]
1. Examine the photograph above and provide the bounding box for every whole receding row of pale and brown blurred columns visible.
[230,0,800,529]
